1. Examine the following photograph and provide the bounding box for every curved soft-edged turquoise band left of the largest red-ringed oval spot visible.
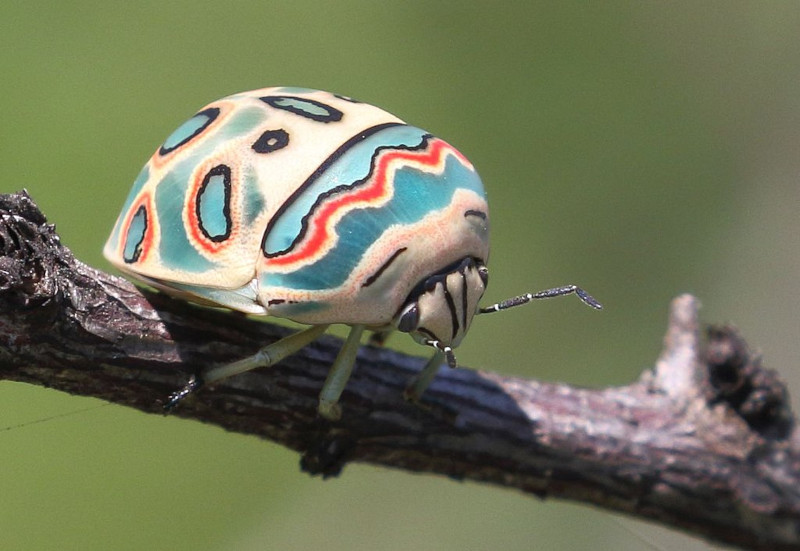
[155,106,267,273]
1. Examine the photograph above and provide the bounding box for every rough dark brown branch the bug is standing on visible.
[0,193,800,550]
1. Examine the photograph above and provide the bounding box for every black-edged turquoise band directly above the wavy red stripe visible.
[264,125,428,254]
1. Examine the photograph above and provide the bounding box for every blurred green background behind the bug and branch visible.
[0,0,800,551]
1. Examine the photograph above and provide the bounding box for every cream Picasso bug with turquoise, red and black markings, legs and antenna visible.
[104,88,601,419]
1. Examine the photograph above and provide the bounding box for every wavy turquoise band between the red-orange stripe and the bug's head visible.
[259,155,485,290]
